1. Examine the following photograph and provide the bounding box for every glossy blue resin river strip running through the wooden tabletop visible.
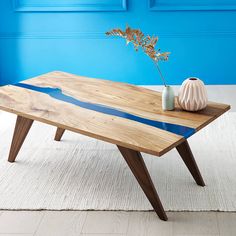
[14,83,195,138]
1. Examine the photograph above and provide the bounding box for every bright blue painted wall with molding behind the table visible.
[0,0,236,84]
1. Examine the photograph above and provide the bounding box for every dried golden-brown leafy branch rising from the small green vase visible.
[106,26,170,86]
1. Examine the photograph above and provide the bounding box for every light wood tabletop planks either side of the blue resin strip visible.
[0,71,230,156]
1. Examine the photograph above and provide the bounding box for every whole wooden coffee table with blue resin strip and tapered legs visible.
[0,71,230,220]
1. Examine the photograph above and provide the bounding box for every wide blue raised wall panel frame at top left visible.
[12,0,127,12]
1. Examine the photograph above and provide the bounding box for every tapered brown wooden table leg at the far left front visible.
[8,116,33,162]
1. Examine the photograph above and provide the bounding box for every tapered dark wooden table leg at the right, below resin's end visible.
[176,140,205,186]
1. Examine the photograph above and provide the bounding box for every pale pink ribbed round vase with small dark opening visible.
[178,78,208,111]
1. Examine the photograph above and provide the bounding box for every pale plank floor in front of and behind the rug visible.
[0,85,236,236]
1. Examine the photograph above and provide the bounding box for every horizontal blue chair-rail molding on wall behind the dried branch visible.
[0,31,236,40]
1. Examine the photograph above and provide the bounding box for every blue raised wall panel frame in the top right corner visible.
[148,0,236,11]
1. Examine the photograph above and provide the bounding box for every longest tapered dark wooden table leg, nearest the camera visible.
[117,146,168,221]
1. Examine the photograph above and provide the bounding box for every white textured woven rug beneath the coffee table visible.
[0,113,236,211]
